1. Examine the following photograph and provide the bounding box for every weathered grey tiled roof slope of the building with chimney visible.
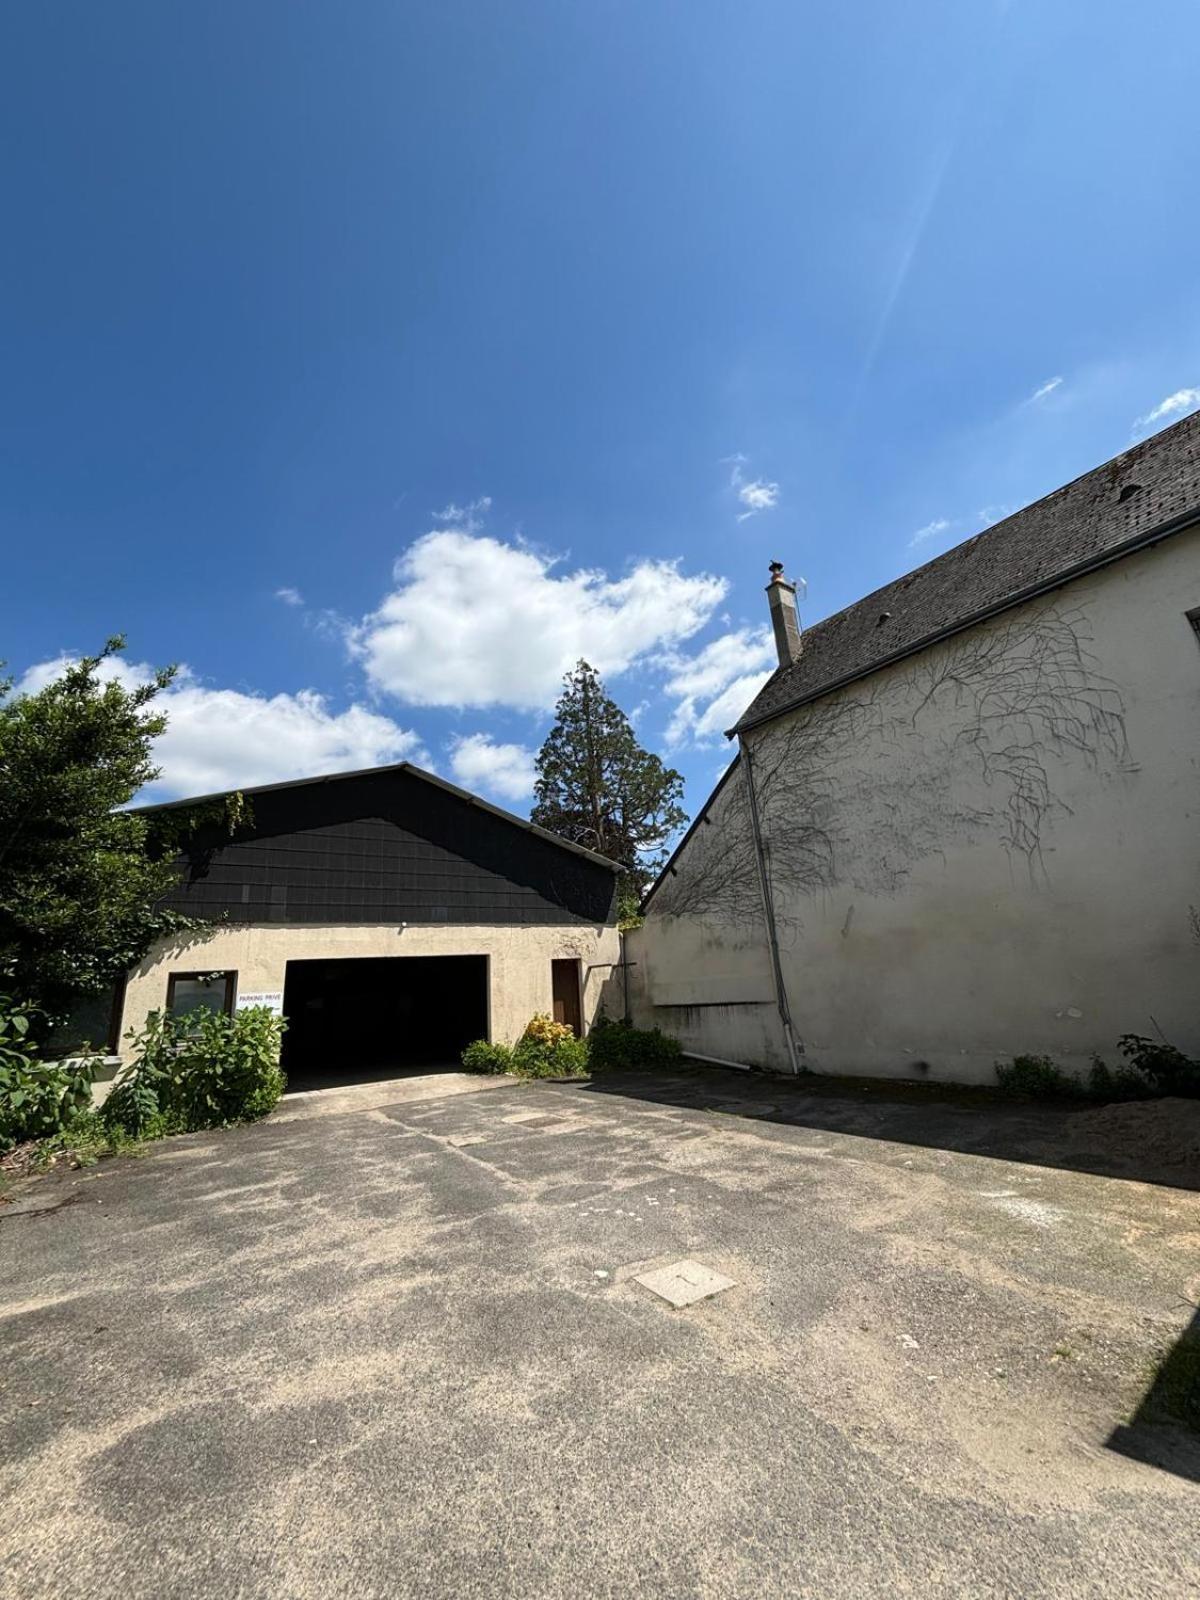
[731,413,1200,733]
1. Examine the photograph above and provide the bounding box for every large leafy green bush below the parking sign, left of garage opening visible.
[104,1006,285,1139]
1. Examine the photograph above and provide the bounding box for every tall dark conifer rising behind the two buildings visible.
[533,661,688,893]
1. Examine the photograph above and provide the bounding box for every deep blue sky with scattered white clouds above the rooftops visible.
[0,0,1200,810]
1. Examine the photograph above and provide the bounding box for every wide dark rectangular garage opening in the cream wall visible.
[283,955,488,1090]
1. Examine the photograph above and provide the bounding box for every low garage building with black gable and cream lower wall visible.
[114,763,621,1082]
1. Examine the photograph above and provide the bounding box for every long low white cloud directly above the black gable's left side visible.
[18,656,429,800]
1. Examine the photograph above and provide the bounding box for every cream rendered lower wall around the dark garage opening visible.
[122,923,621,1043]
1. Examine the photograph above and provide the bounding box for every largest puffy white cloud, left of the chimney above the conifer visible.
[349,528,728,710]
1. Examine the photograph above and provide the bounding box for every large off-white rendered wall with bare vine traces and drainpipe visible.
[630,531,1200,1082]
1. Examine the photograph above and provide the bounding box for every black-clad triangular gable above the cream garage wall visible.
[157,771,616,925]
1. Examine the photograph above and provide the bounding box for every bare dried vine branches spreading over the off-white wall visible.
[654,603,1131,923]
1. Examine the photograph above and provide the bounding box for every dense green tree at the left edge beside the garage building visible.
[0,637,195,1022]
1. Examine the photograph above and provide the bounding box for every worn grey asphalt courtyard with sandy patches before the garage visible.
[0,1072,1200,1600]
